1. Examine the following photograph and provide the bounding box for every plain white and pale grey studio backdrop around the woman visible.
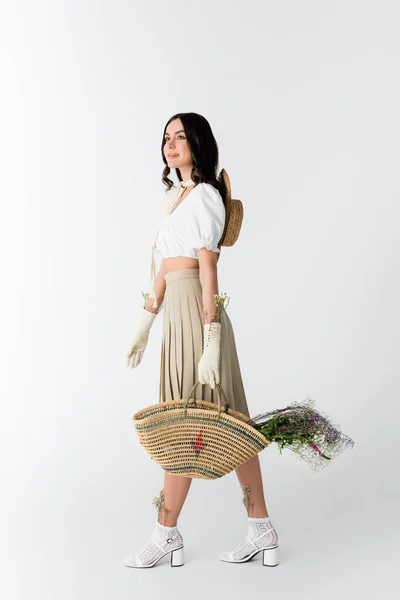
[0,0,400,600]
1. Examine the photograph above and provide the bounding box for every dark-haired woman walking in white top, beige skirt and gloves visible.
[125,113,278,567]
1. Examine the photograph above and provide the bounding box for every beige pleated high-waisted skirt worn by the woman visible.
[160,268,250,416]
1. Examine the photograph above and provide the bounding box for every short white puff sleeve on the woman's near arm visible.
[193,183,225,252]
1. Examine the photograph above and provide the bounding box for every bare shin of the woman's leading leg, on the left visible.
[153,472,192,527]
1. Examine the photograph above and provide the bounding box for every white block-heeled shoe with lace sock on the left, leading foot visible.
[125,521,184,568]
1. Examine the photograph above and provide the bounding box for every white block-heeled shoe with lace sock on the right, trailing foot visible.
[219,517,279,567]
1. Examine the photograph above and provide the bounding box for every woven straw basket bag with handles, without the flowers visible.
[132,381,271,479]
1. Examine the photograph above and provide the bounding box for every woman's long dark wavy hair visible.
[161,113,226,203]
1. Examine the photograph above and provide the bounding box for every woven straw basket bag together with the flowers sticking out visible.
[132,381,354,479]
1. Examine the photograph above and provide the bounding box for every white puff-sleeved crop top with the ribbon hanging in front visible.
[151,179,225,308]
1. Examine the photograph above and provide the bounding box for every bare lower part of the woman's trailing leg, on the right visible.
[236,454,268,518]
